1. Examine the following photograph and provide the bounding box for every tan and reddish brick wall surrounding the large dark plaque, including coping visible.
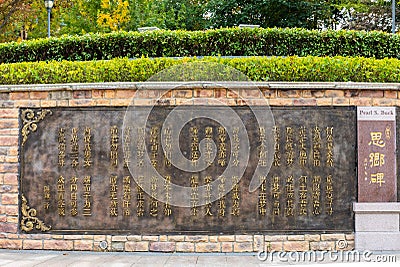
[0,83,400,252]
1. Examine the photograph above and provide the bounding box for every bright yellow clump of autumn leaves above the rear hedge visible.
[97,0,130,31]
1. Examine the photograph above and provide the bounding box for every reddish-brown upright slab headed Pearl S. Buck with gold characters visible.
[357,107,397,202]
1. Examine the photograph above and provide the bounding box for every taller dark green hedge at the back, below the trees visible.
[0,28,400,63]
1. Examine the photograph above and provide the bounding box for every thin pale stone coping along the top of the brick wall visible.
[0,81,400,93]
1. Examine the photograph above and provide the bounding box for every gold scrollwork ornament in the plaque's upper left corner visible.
[21,109,53,146]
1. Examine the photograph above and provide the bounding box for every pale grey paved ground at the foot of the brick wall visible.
[0,249,400,267]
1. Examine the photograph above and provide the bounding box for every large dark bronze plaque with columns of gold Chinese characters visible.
[20,106,356,234]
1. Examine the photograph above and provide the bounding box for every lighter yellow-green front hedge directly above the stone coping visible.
[0,56,400,84]
